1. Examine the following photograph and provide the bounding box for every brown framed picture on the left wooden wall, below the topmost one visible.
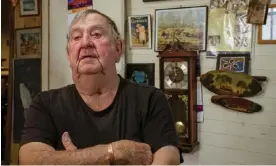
[15,28,41,58]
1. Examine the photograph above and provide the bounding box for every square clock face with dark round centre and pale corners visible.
[164,61,188,90]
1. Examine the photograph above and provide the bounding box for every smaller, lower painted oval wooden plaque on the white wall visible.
[211,95,262,113]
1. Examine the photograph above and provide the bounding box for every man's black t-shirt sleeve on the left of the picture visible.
[21,93,56,147]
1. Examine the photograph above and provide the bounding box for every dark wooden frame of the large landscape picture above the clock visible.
[152,5,209,52]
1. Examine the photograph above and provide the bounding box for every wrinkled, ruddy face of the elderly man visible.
[67,13,122,74]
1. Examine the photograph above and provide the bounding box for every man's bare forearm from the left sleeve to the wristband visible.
[20,145,110,165]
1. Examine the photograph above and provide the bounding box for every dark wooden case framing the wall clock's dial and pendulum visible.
[157,51,199,152]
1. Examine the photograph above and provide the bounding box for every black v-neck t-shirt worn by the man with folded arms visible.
[21,77,182,161]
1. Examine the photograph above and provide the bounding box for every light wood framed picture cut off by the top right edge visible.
[258,4,276,44]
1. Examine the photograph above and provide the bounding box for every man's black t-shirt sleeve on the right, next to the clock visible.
[143,90,183,162]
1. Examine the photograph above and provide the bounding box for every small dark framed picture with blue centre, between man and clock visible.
[126,63,155,86]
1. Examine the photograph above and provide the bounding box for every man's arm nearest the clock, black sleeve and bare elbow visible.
[144,90,183,165]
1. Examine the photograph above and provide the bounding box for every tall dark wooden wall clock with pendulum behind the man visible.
[157,51,199,152]
